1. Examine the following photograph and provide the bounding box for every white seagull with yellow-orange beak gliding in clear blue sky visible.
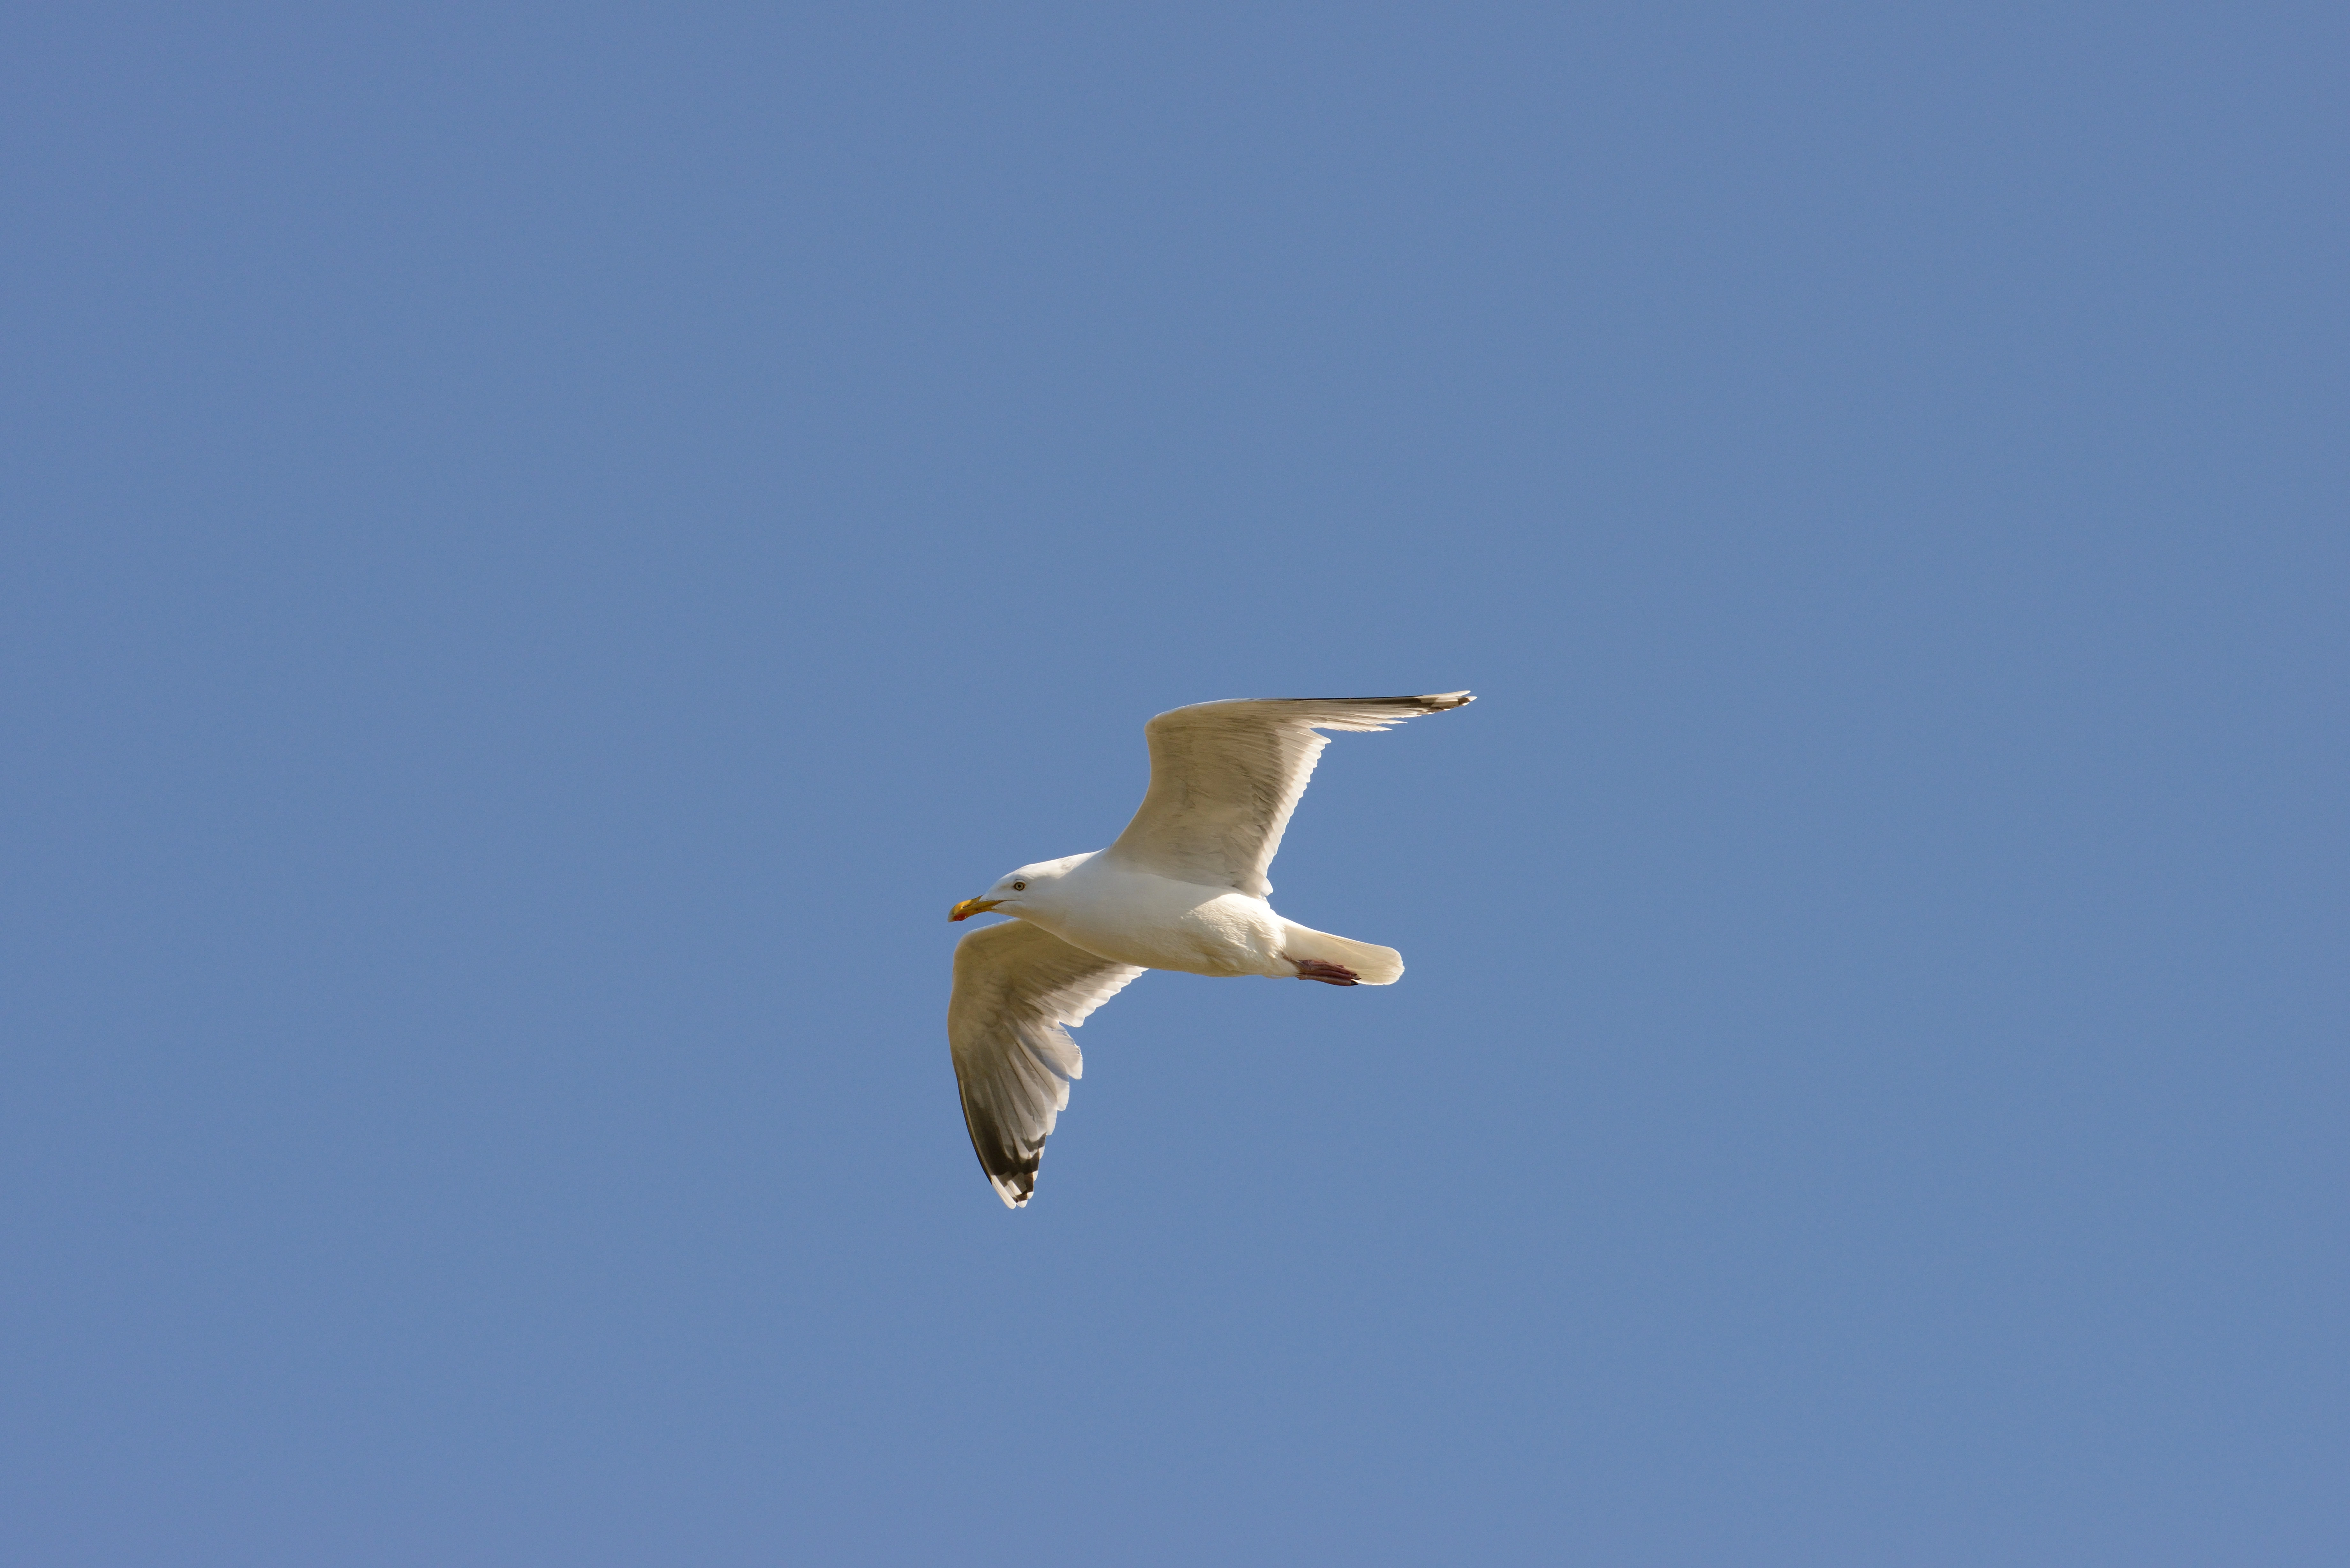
[947,691,1476,1208]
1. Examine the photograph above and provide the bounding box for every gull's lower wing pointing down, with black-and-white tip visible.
[947,919,1142,1208]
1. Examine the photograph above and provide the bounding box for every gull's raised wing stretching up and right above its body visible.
[1109,691,1476,898]
